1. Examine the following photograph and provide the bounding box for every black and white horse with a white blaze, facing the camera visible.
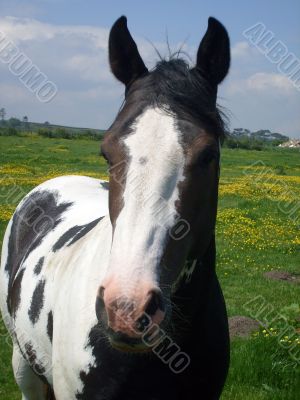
[0,16,230,400]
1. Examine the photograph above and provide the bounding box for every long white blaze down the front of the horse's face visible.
[110,108,185,287]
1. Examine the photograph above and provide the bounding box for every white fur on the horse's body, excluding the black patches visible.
[0,176,111,400]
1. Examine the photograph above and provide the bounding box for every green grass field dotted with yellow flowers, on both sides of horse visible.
[0,136,300,400]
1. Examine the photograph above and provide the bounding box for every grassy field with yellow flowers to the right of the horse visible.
[217,149,300,400]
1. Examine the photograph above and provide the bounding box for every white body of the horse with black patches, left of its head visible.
[0,176,111,399]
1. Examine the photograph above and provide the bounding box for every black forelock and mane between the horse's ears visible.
[117,58,226,139]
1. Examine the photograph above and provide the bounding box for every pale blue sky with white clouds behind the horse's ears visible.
[0,0,300,138]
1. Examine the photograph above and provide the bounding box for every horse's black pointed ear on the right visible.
[196,17,230,85]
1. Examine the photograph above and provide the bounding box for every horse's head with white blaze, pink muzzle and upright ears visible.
[96,17,230,345]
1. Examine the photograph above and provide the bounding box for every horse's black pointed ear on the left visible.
[108,16,148,86]
